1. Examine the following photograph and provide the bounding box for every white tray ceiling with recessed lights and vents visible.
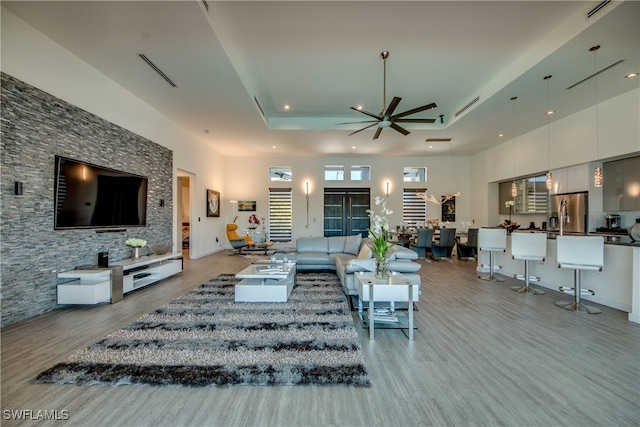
[2,0,640,156]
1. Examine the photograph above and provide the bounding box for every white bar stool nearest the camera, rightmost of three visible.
[556,236,604,314]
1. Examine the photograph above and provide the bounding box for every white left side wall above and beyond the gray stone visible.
[1,8,226,258]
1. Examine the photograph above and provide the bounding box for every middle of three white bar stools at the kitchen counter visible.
[511,231,547,295]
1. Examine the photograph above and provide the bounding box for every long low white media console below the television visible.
[58,253,182,304]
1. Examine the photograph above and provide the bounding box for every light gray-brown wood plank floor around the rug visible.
[0,252,640,426]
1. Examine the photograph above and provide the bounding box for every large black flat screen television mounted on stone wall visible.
[54,156,148,230]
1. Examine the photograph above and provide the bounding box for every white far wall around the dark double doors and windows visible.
[221,156,474,240]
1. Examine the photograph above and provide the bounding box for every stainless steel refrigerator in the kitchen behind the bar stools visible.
[547,191,589,234]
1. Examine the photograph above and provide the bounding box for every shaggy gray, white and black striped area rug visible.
[33,273,371,386]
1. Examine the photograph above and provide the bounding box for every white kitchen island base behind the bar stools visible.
[477,234,640,323]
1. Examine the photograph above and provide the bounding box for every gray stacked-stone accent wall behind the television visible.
[0,73,173,327]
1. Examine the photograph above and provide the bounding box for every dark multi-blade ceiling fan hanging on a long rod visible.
[338,50,437,139]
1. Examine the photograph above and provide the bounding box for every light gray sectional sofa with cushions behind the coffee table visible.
[278,235,422,295]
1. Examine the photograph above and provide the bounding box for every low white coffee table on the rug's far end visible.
[235,261,296,302]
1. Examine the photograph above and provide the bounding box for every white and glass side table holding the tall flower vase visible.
[354,272,419,340]
